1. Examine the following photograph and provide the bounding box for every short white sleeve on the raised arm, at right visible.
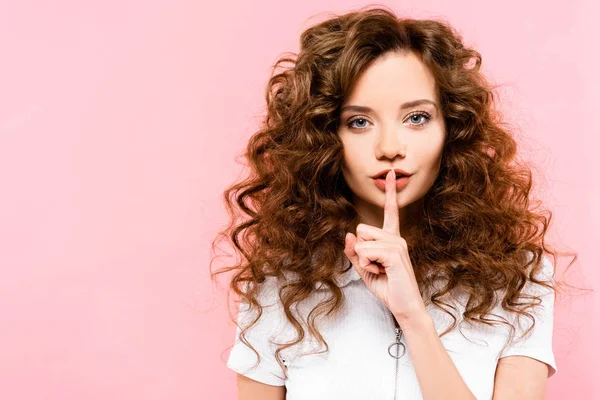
[498,256,558,378]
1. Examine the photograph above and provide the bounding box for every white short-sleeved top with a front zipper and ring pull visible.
[227,257,557,400]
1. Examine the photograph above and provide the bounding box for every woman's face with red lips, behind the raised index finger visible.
[338,53,446,236]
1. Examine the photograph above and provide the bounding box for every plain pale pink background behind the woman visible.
[0,0,600,400]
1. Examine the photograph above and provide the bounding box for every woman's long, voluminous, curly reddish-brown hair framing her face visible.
[211,7,577,378]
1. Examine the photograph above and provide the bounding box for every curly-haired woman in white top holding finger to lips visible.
[212,8,576,400]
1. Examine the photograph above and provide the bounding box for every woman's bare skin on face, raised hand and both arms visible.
[233,54,548,400]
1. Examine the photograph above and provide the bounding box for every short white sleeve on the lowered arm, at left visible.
[227,277,285,386]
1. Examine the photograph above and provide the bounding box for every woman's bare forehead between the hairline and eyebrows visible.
[345,52,437,107]
